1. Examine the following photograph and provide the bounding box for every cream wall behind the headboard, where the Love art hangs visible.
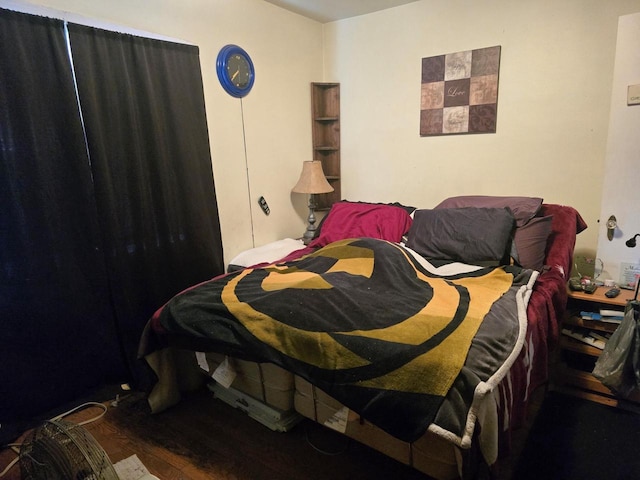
[324,0,640,255]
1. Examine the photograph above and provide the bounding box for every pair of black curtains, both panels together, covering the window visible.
[0,9,224,439]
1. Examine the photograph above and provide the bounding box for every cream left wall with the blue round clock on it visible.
[6,0,322,262]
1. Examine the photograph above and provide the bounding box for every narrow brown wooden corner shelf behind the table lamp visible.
[311,82,342,210]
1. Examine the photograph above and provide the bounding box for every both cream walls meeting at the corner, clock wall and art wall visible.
[5,0,640,261]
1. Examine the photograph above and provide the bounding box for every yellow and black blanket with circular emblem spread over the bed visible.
[152,238,529,441]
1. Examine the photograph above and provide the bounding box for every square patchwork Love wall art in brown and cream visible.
[420,46,501,137]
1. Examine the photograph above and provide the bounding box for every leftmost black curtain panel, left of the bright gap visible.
[0,9,126,438]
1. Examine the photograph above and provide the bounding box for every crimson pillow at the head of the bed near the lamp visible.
[309,202,411,247]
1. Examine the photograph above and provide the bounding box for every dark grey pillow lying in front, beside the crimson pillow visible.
[407,207,515,265]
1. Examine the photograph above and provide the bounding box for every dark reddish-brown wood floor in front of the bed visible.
[0,389,540,480]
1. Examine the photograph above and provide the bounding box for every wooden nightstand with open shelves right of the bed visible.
[552,287,640,412]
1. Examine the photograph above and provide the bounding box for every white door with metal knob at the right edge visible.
[597,13,640,282]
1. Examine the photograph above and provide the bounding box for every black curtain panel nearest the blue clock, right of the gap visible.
[69,24,224,381]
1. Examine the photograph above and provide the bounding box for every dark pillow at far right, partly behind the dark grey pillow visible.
[513,215,553,271]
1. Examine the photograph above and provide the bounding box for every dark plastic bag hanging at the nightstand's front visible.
[593,301,640,397]
